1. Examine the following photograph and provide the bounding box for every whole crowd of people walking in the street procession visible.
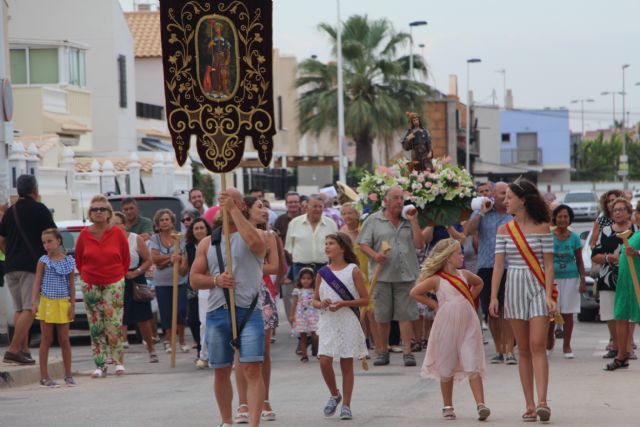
[0,175,640,426]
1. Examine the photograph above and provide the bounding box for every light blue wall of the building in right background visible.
[500,109,571,168]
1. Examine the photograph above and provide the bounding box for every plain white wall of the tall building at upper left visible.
[9,0,136,151]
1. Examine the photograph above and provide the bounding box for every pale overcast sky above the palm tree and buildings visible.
[120,0,640,132]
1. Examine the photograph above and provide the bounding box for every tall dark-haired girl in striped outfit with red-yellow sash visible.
[489,178,556,422]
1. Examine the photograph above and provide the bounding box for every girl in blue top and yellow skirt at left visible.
[32,228,76,388]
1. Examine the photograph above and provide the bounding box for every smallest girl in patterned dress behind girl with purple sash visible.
[289,267,318,363]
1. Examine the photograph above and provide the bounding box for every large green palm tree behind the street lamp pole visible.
[296,15,429,168]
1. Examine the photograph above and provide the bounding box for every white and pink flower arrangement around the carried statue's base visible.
[358,158,476,227]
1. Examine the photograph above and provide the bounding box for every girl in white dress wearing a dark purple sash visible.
[313,233,369,420]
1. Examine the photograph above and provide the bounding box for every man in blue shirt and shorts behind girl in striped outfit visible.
[465,182,518,365]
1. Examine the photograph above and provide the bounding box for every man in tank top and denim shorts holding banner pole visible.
[190,188,267,426]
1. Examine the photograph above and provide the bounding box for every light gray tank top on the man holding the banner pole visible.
[207,232,263,312]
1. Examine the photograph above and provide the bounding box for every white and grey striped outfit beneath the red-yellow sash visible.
[496,233,553,320]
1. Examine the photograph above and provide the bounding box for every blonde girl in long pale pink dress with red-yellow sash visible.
[410,238,491,421]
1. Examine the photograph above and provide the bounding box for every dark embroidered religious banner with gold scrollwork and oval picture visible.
[160,0,275,173]
